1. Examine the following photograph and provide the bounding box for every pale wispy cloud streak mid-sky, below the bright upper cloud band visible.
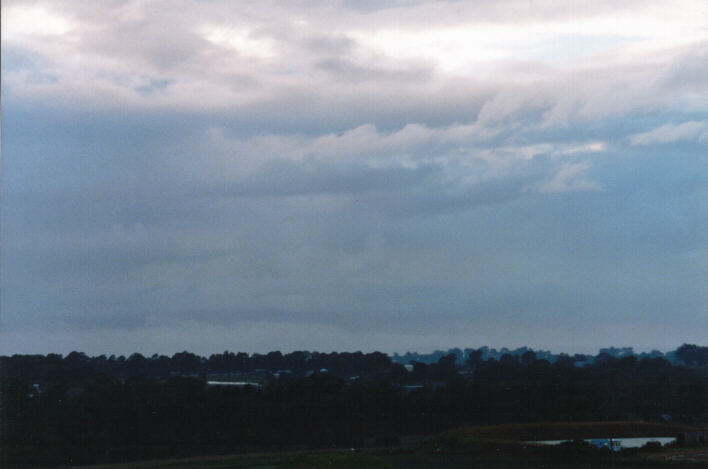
[165,123,607,194]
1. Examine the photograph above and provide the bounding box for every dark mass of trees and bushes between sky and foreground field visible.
[0,344,708,467]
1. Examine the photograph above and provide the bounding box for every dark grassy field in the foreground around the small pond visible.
[74,422,708,469]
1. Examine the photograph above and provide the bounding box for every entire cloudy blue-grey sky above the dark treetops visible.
[0,0,708,354]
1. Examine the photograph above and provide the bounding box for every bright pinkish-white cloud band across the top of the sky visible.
[2,0,708,127]
